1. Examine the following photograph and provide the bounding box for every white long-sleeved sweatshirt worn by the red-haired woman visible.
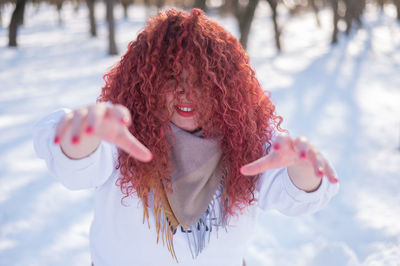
[34,109,339,266]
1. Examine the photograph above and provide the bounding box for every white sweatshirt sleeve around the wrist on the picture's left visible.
[33,109,117,190]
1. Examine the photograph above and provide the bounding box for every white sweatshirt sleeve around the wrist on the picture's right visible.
[257,168,339,216]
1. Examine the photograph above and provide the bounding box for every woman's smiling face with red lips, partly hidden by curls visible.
[166,71,200,132]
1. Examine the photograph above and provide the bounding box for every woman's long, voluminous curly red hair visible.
[99,9,282,218]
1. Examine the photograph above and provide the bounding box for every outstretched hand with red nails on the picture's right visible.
[240,135,338,183]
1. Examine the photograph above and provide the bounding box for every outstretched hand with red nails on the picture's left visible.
[54,103,153,162]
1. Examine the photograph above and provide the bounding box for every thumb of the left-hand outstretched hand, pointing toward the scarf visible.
[115,126,153,162]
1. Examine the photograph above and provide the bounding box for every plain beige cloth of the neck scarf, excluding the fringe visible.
[166,123,222,229]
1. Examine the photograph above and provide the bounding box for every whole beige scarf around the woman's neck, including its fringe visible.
[145,123,223,259]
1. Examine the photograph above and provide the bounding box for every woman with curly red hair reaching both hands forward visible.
[34,9,338,266]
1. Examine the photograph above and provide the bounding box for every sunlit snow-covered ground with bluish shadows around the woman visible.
[0,2,400,266]
